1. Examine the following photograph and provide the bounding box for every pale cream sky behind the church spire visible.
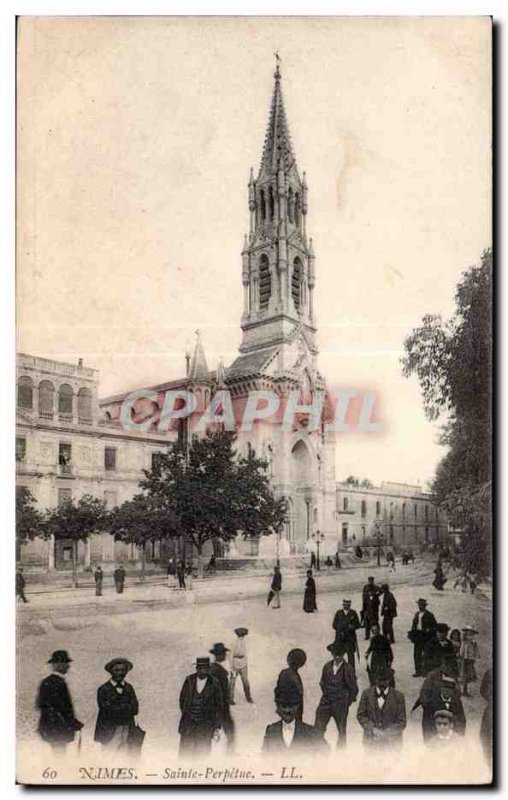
[17,17,491,485]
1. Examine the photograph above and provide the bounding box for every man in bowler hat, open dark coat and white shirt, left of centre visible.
[178,658,222,756]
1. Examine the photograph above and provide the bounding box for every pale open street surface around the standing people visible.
[18,565,491,784]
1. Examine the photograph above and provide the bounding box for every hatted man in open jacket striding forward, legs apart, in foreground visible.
[314,642,358,747]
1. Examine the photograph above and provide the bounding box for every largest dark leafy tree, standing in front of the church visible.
[140,431,287,574]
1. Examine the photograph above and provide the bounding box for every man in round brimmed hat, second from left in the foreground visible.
[94,658,139,752]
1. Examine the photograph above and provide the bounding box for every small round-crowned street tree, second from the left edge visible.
[46,494,108,587]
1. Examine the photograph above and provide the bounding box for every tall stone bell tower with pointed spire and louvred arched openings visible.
[240,62,317,356]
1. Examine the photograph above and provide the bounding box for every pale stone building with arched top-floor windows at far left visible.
[16,354,168,570]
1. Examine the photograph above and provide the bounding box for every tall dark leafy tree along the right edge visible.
[402,249,492,574]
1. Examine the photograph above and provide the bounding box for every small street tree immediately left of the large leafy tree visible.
[108,494,176,580]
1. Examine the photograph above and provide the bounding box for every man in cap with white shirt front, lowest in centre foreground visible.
[262,683,327,755]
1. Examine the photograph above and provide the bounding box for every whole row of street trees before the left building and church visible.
[16,431,287,584]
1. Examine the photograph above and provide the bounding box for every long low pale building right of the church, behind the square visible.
[336,481,448,550]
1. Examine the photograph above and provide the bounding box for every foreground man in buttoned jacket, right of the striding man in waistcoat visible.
[356,667,406,749]
